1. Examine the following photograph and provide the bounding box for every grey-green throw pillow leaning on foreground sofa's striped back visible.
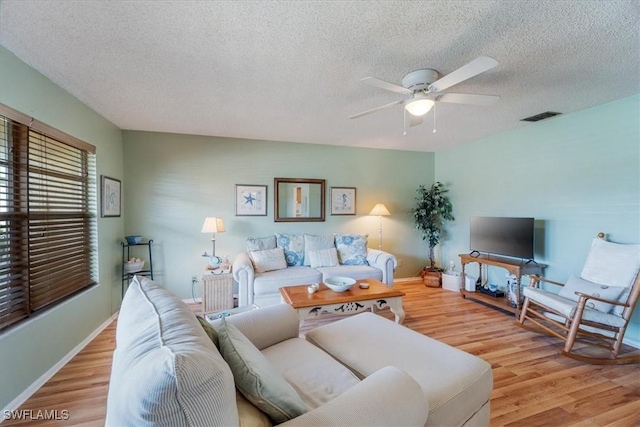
[218,318,307,424]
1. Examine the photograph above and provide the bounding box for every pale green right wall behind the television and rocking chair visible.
[436,95,640,344]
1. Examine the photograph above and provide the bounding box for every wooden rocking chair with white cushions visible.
[516,233,640,365]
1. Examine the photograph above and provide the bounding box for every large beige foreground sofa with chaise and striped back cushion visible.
[106,278,492,426]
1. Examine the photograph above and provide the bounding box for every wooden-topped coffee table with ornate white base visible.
[280,279,404,324]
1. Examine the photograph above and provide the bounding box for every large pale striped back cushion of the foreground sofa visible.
[106,277,238,426]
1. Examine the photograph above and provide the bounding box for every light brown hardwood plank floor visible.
[3,283,640,427]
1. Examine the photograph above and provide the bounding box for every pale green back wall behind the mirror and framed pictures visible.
[123,131,435,298]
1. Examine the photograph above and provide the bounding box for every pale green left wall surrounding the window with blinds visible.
[0,46,124,409]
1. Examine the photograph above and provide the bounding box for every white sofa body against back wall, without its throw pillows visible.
[232,234,398,307]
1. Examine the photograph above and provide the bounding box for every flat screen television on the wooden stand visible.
[469,216,534,259]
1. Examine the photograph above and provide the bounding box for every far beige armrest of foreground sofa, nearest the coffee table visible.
[211,304,300,350]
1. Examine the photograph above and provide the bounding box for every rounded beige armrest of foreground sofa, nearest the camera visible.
[280,366,429,427]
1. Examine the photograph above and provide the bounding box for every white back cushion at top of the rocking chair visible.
[580,239,640,316]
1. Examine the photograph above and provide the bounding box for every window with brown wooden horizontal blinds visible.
[0,104,97,330]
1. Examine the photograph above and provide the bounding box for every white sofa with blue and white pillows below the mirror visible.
[232,233,398,307]
